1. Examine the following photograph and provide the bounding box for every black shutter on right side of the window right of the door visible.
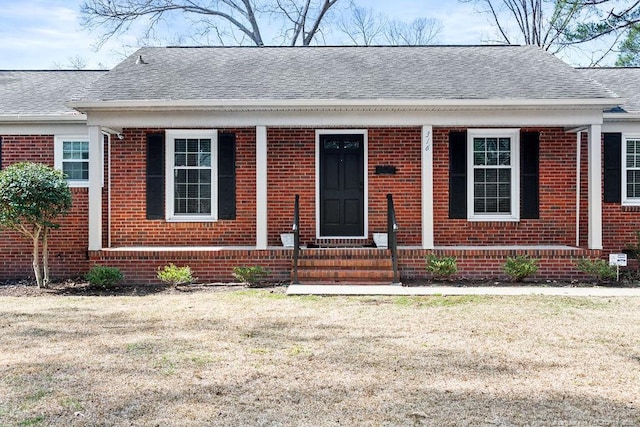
[520,132,540,219]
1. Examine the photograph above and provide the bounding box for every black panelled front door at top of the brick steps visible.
[320,134,364,237]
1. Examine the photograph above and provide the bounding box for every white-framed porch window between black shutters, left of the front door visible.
[166,130,218,221]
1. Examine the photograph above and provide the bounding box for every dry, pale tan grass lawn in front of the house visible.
[0,290,640,426]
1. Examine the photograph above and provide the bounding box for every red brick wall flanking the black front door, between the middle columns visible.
[267,127,422,245]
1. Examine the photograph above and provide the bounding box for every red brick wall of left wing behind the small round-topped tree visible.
[0,135,89,279]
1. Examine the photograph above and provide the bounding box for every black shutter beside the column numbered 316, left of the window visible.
[449,132,467,219]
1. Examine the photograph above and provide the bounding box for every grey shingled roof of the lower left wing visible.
[0,70,106,119]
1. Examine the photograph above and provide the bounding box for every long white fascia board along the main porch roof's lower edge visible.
[66,98,624,112]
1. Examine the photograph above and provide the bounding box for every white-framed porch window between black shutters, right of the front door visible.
[467,129,520,221]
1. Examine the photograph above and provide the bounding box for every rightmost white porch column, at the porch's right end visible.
[587,125,602,249]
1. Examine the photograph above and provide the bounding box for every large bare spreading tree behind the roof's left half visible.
[80,0,339,46]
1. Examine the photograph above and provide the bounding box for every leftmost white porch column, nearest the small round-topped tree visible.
[89,126,104,251]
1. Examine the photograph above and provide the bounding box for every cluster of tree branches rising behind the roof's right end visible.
[460,0,640,65]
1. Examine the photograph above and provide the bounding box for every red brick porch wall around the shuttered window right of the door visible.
[433,128,576,246]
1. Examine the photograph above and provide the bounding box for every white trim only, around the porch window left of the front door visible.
[165,129,218,222]
